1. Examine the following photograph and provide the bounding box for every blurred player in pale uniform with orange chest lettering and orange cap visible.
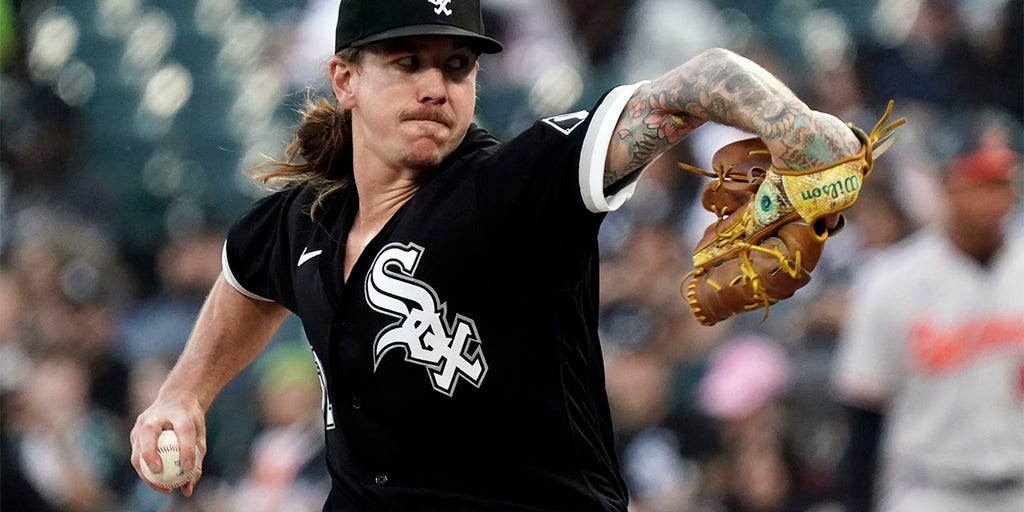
[835,148,1024,512]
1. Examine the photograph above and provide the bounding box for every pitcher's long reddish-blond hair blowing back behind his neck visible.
[247,48,361,216]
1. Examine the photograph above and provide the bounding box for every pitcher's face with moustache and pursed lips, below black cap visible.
[331,36,478,169]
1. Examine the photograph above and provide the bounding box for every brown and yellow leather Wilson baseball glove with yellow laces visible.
[679,101,904,326]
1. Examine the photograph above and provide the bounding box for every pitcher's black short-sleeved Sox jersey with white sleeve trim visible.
[224,81,636,512]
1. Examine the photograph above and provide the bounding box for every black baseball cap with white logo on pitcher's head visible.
[334,0,502,53]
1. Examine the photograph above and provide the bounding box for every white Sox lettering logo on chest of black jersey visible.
[366,243,487,396]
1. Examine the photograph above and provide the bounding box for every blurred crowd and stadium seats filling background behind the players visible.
[0,0,1024,512]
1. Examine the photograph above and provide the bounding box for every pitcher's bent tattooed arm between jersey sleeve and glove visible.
[605,49,860,185]
